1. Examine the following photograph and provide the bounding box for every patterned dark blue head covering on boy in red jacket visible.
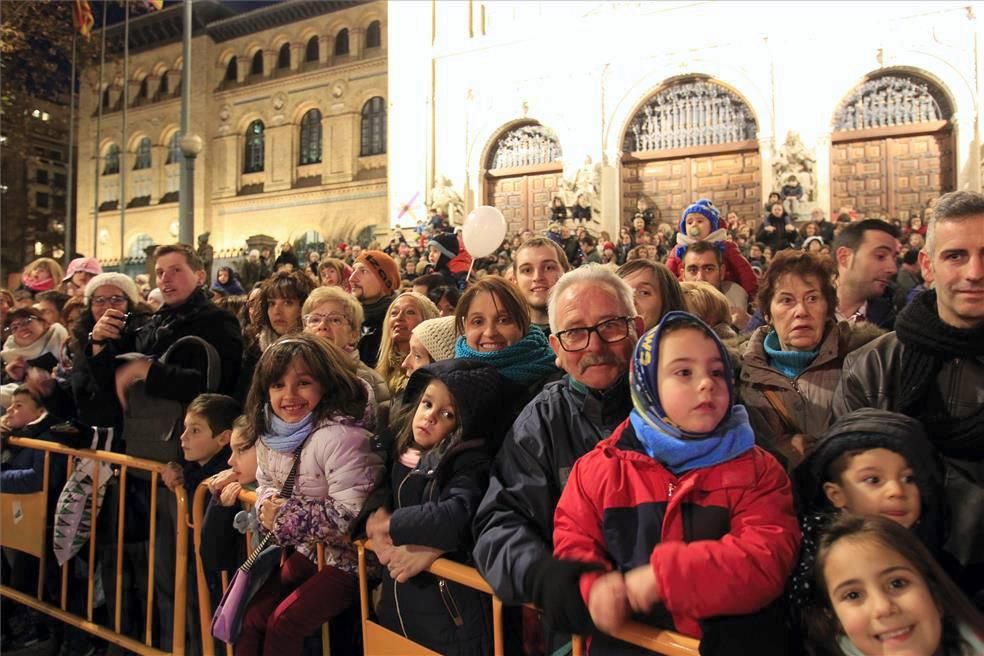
[629,311,736,437]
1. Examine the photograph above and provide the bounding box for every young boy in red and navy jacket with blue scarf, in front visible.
[554,312,800,656]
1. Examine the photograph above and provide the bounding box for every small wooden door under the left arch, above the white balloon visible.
[486,172,563,234]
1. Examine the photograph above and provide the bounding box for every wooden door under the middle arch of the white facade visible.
[622,150,762,225]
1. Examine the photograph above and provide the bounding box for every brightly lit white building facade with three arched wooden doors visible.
[388,0,984,234]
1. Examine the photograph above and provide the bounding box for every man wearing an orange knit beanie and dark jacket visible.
[349,246,400,368]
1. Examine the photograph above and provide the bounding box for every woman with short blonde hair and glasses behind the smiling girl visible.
[301,287,390,428]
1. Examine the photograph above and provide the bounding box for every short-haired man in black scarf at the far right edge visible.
[833,191,984,594]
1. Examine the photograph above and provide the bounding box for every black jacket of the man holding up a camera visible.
[86,289,243,403]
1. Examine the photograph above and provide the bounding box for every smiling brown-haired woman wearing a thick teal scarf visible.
[454,276,563,450]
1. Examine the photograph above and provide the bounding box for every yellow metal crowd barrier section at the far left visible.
[0,437,188,656]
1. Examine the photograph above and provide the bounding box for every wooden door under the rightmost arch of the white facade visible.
[830,130,956,222]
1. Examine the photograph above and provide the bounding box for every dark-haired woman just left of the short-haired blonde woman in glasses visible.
[235,271,315,403]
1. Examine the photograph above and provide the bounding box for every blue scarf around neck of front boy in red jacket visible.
[629,405,755,476]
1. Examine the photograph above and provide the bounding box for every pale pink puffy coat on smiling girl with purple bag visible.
[256,404,383,573]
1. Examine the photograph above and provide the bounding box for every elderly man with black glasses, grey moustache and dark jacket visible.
[474,264,644,653]
